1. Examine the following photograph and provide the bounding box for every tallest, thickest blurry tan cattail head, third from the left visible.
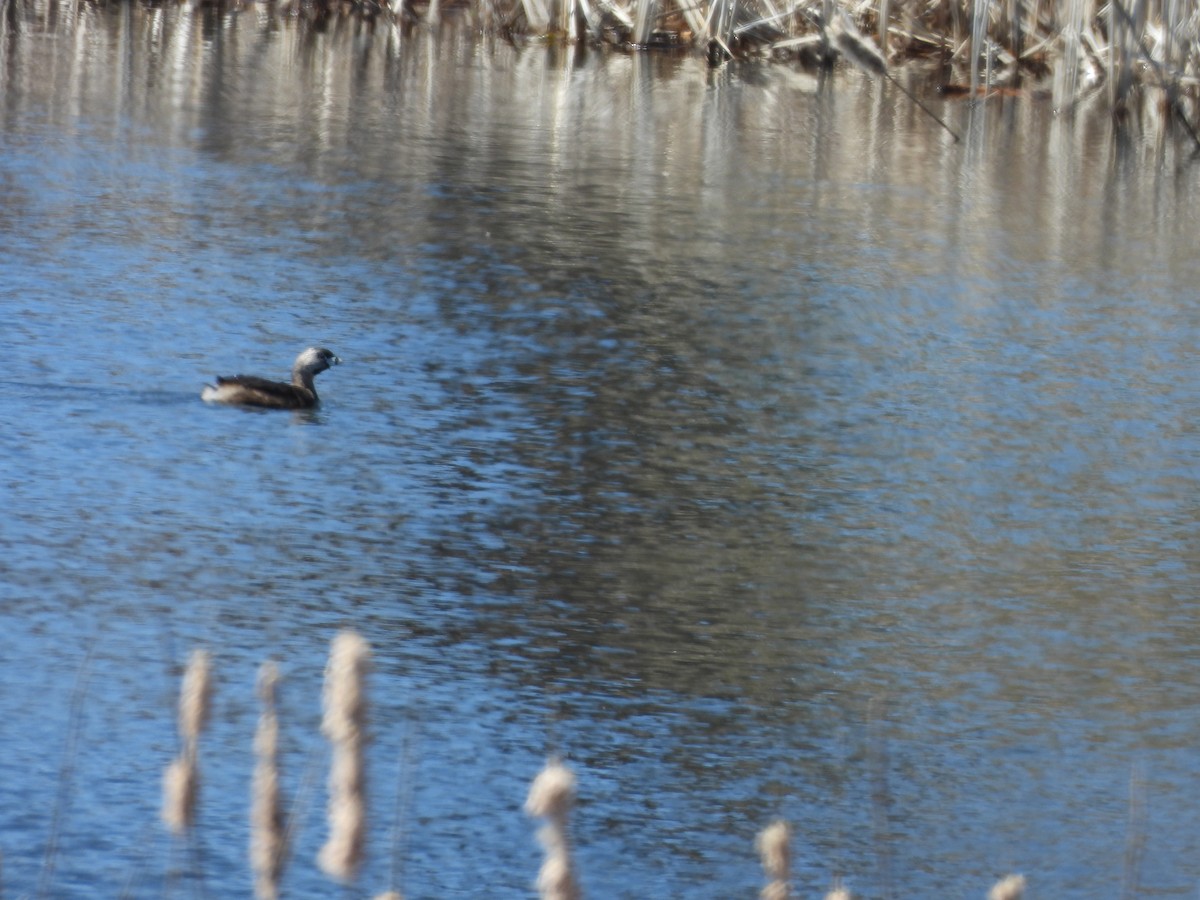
[317,630,371,881]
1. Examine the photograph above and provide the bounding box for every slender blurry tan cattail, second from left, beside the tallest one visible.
[250,661,288,900]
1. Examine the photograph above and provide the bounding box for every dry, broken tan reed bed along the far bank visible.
[231,0,1200,113]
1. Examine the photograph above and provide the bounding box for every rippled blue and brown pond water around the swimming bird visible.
[0,5,1200,898]
